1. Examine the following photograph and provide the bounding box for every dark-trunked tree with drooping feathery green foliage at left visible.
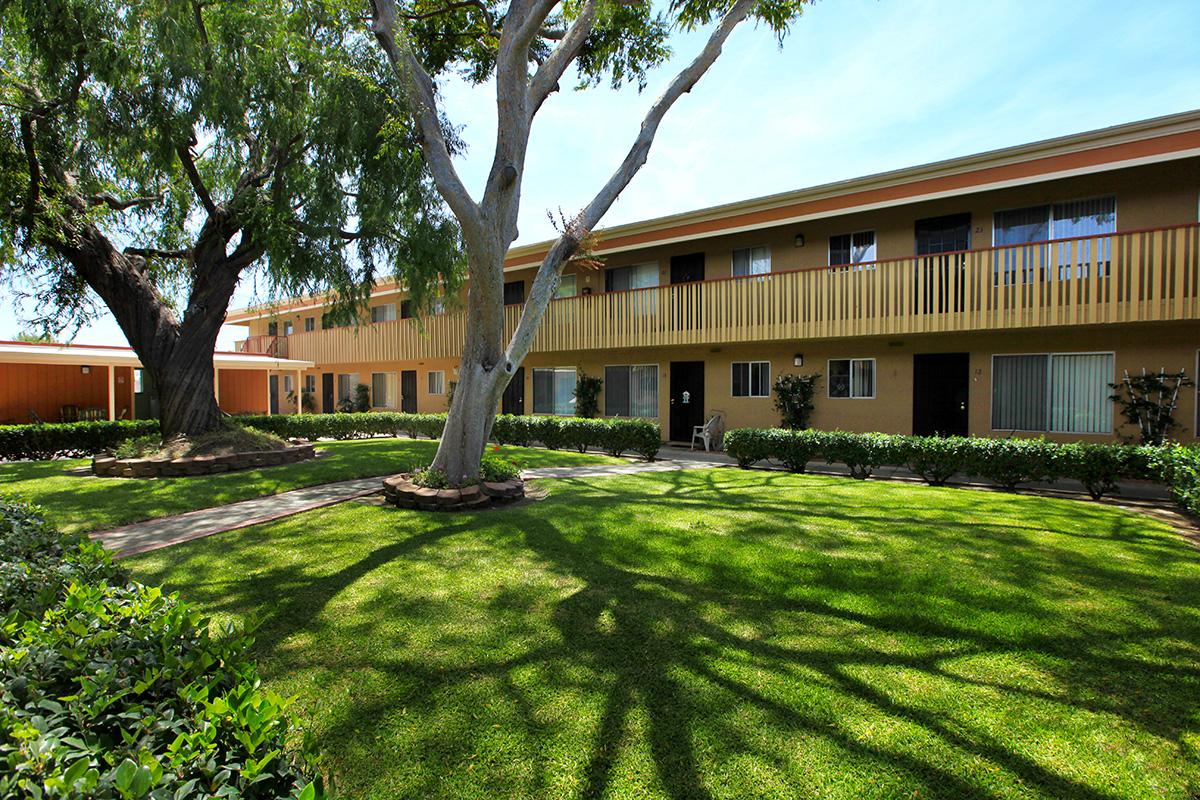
[0,0,461,437]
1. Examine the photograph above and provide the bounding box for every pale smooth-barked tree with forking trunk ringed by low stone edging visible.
[371,0,804,482]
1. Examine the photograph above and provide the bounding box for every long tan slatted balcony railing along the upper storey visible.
[289,224,1200,363]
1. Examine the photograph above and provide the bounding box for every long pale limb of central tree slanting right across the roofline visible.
[505,0,758,372]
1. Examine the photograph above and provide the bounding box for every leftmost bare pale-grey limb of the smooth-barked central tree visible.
[371,0,482,242]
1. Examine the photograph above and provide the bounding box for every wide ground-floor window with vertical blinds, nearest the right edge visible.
[991,353,1114,433]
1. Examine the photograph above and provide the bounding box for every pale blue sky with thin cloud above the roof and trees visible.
[0,0,1200,347]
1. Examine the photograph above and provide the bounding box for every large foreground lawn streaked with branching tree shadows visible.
[131,470,1200,800]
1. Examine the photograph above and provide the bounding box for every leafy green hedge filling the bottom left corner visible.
[0,504,320,800]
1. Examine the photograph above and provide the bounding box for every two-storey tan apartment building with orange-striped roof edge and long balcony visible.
[228,112,1200,440]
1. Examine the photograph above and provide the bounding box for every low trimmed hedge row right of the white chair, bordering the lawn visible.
[725,428,1156,509]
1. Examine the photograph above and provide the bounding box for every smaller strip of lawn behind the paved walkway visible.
[0,439,617,531]
